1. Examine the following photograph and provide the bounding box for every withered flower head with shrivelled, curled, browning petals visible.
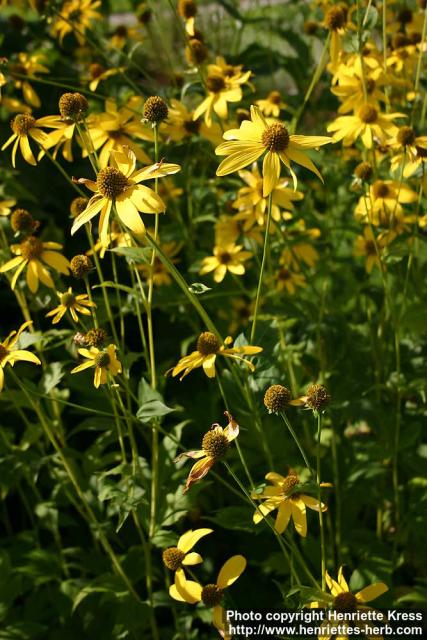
[175,411,239,493]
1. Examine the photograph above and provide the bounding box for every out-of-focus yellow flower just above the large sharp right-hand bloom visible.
[193,59,251,127]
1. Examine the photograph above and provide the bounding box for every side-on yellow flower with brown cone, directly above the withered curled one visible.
[172,331,262,380]
